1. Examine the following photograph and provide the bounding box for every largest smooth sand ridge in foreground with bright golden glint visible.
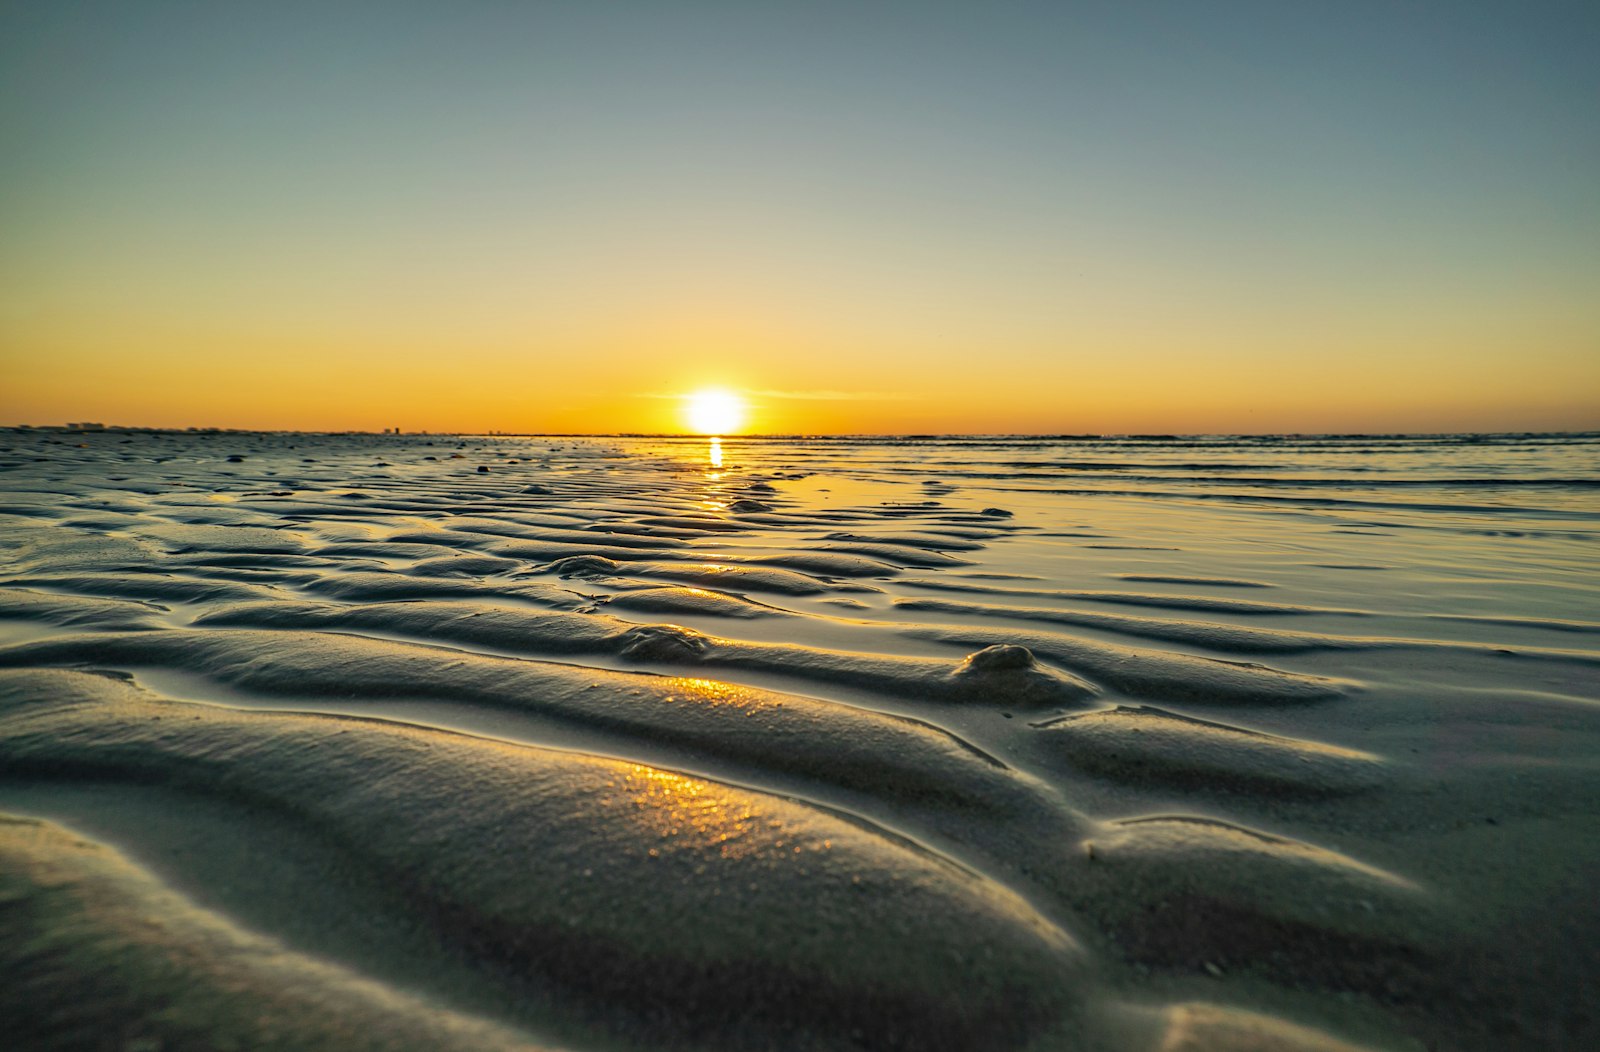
[0,671,1077,1047]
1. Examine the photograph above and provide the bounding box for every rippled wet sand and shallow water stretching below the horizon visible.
[0,432,1600,1050]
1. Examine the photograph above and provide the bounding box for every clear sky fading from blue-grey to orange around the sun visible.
[0,0,1600,433]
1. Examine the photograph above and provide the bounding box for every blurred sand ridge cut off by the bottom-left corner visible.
[0,814,550,1052]
